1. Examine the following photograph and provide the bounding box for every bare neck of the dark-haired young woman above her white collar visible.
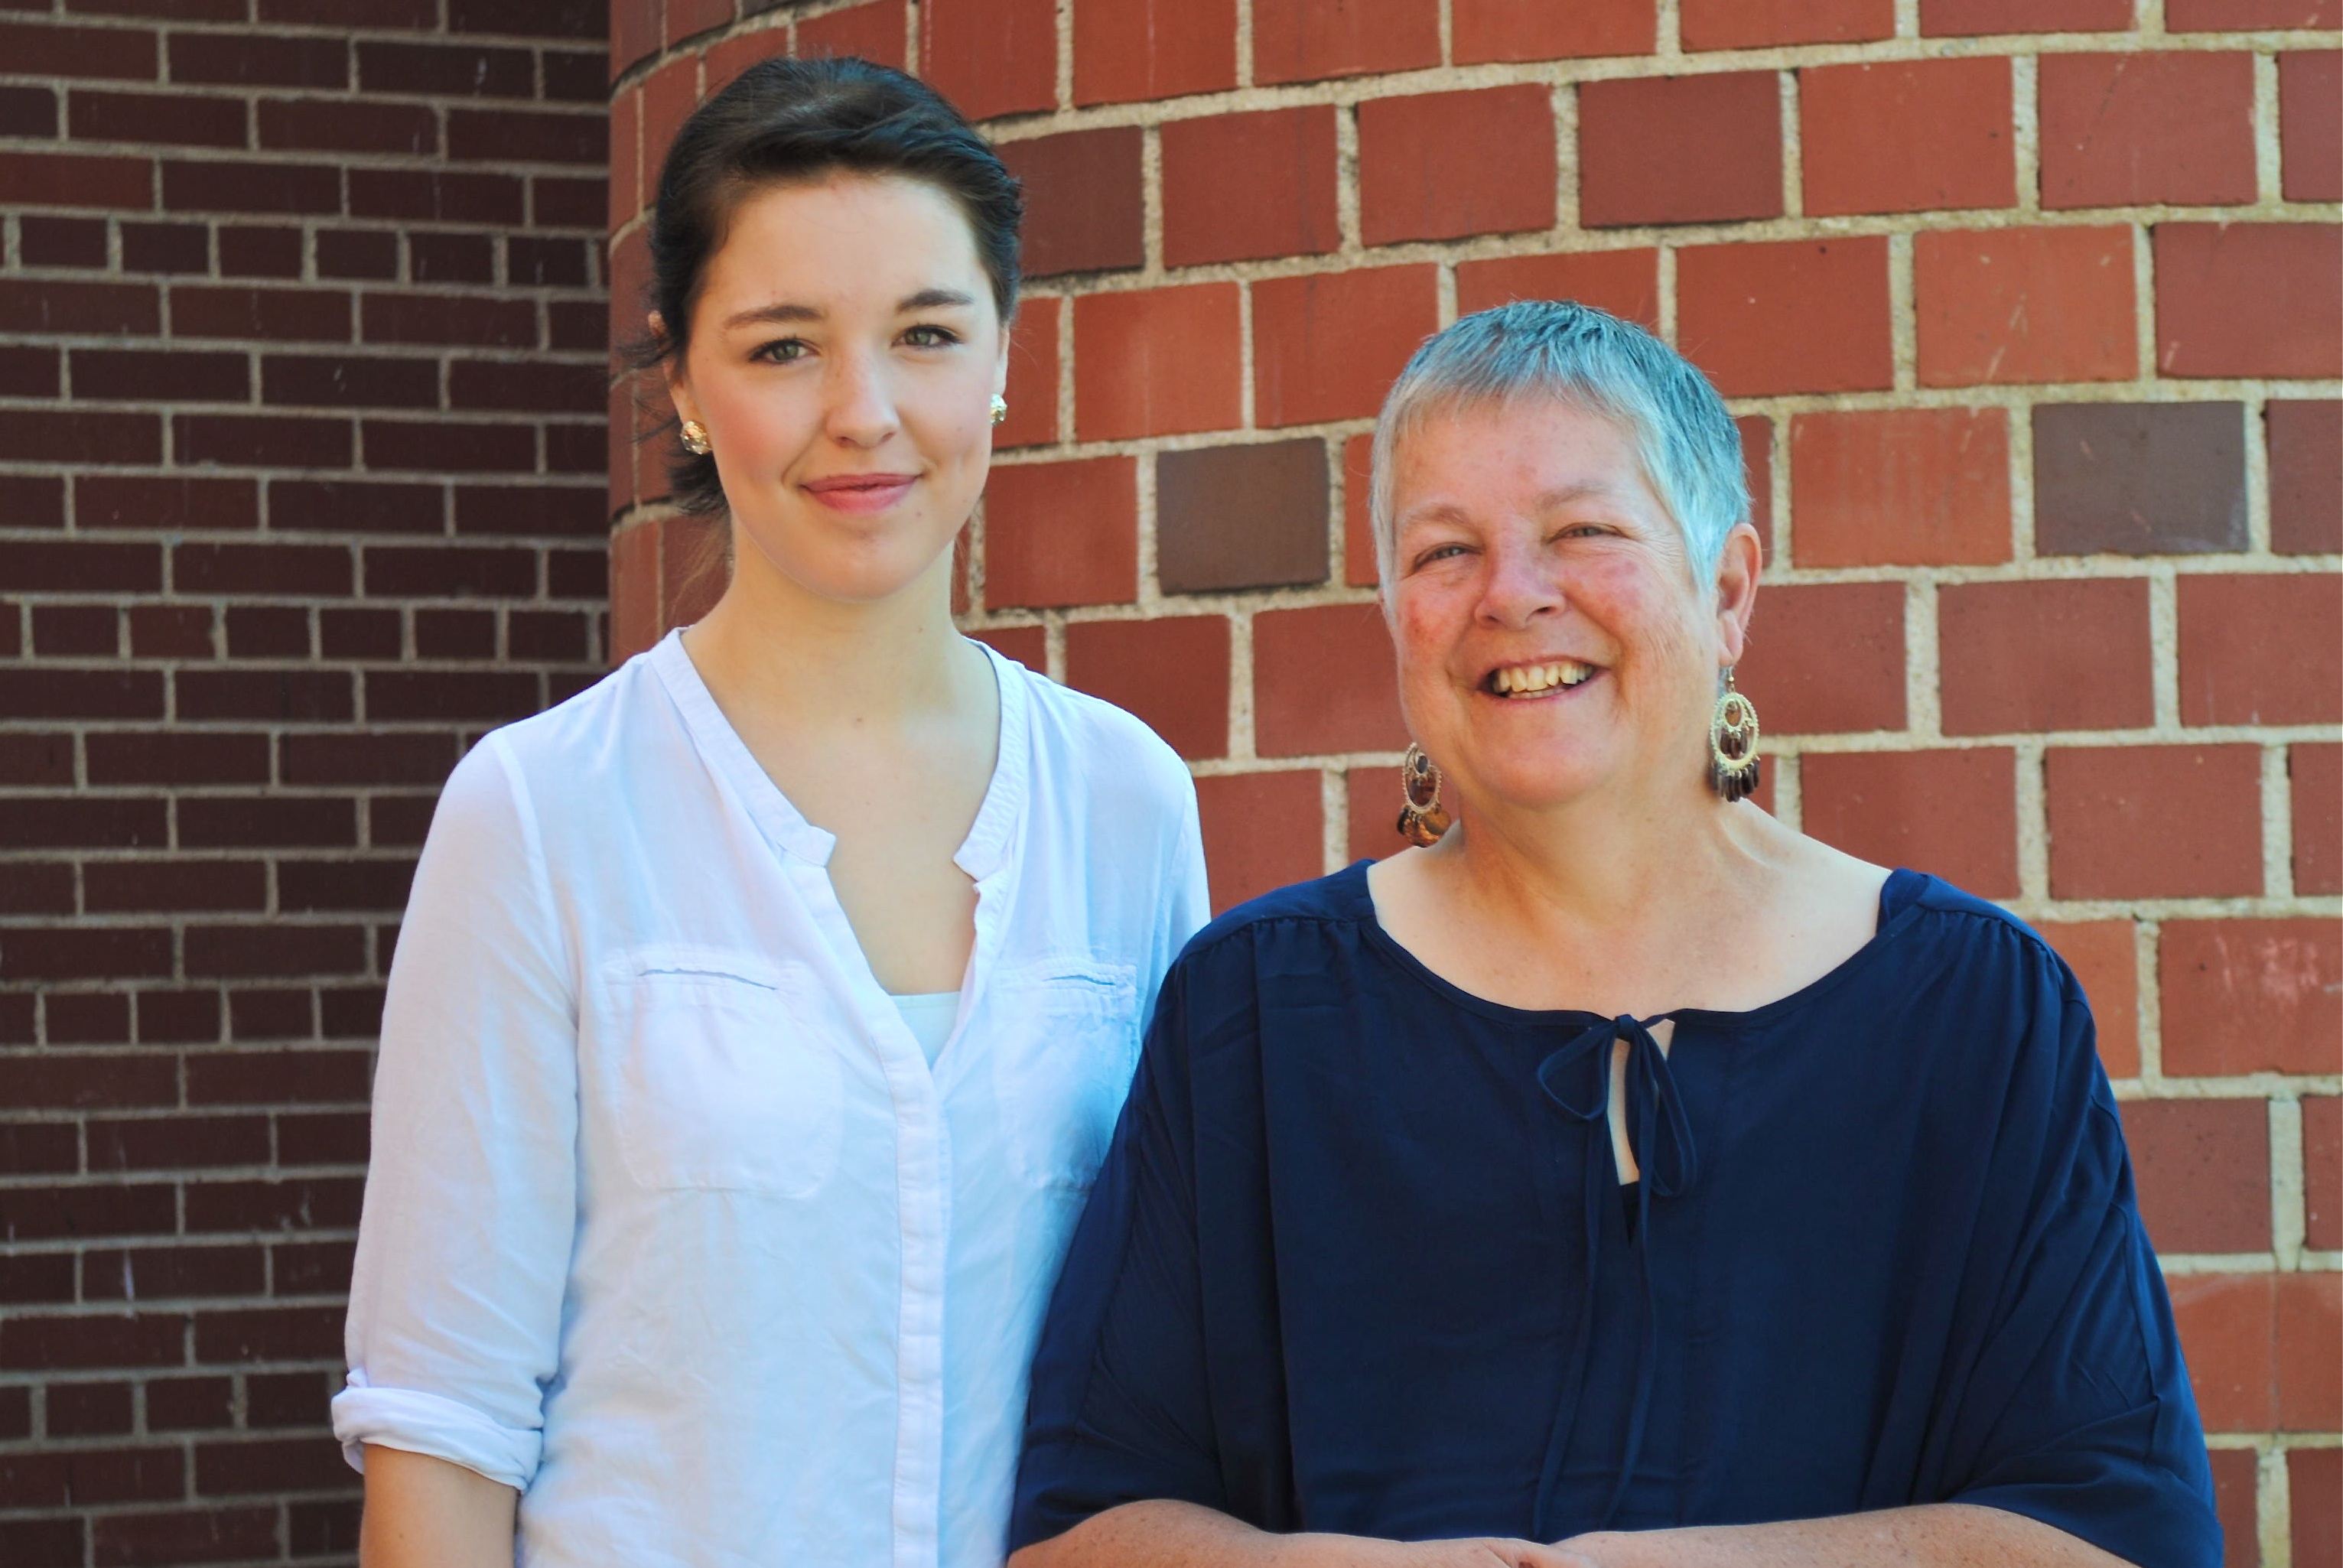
[684,544,991,734]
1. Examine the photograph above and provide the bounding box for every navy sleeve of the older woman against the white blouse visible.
[1010,968,1228,1552]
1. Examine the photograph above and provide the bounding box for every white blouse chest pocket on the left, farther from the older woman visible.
[604,952,846,1198]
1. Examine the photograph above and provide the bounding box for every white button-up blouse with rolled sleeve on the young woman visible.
[333,635,1206,1568]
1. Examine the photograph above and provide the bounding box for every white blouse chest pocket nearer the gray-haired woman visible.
[991,958,1139,1193]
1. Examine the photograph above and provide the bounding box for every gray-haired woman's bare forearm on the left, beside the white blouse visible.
[1010,1502,1596,1568]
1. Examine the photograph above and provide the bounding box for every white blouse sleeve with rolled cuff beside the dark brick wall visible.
[333,734,579,1491]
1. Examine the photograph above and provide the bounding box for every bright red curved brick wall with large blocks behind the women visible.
[609,0,2343,1568]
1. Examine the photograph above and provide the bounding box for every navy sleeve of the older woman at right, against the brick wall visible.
[1935,952,2221,1568]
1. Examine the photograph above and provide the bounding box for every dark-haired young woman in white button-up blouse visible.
[335,61,1204,1568]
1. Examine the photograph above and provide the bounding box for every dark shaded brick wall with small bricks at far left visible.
[0,0,609,1568]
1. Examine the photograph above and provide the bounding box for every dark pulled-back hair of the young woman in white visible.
[626,57,1024,516]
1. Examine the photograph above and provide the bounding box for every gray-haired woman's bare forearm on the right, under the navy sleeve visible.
[1563,1502,2125,1568]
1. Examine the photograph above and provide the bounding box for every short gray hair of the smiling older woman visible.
[1371,300,1750,590]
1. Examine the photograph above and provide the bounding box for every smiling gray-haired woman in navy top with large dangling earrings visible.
[1010,304,2221,1568]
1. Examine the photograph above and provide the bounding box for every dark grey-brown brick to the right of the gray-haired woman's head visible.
[2034,403,2247,555]
